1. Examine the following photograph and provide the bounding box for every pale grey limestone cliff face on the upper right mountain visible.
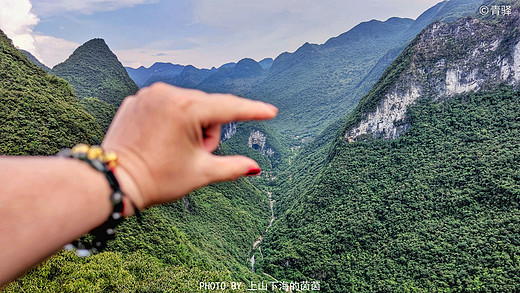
[345,9,520,142]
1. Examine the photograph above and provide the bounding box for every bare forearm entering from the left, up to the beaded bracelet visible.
[0,157,111,284]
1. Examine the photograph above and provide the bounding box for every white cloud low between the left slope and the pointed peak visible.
[34,34,80,68]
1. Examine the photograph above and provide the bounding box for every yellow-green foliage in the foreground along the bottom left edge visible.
[2,251,240,293]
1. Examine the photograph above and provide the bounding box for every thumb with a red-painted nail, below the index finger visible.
[198,154,261,184]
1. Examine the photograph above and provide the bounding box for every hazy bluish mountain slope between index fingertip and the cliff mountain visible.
[244,18,412,138]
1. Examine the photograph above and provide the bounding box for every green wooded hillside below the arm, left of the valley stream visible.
[4,179,269,292]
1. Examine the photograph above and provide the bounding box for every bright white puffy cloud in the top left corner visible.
[0,0,39,58]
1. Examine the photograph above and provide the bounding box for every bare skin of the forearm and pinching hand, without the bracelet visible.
[0,83,278,286]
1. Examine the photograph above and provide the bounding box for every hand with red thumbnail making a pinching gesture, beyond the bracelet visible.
[102,83,278,209]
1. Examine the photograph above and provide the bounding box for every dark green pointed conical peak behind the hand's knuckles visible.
[51,39,139,106]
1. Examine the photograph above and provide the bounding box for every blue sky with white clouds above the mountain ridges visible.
[0,0,441,68]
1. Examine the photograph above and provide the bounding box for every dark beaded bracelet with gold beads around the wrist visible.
[58,144,139,257]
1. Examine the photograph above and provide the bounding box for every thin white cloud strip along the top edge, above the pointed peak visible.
[33,0,158,16]
